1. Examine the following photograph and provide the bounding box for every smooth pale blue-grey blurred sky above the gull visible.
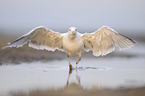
[0,0,145,35]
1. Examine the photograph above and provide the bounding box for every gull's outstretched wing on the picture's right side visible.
[82,26,135,56]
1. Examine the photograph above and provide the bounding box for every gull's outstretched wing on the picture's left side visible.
[4,27,63,51]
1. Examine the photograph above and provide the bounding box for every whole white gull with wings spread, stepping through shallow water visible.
[3,26,135,69]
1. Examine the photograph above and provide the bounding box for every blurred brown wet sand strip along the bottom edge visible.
[11,85,145,96]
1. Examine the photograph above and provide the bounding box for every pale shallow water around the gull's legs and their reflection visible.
[0,44,145,96]
